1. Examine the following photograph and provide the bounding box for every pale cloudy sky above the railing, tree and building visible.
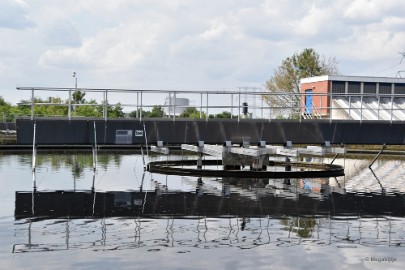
[0,0,405,103]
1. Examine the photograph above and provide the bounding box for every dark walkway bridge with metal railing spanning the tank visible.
[12,87,405,147]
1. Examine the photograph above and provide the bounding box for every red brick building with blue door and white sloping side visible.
[301,75,405,121]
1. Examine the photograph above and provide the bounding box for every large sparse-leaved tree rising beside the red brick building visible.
[263,49,338,118]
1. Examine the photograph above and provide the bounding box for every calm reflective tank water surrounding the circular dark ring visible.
[0,152,405,269]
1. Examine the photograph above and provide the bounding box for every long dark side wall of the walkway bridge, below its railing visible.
[17,119,405,145]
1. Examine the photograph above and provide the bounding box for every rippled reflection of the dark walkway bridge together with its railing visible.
[13,175,405,252]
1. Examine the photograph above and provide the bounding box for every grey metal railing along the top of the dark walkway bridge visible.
[17,87,405,122]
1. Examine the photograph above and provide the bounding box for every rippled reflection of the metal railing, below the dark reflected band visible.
[12,216,405,253]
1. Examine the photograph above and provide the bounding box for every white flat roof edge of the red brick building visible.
[301,75,405,83]
